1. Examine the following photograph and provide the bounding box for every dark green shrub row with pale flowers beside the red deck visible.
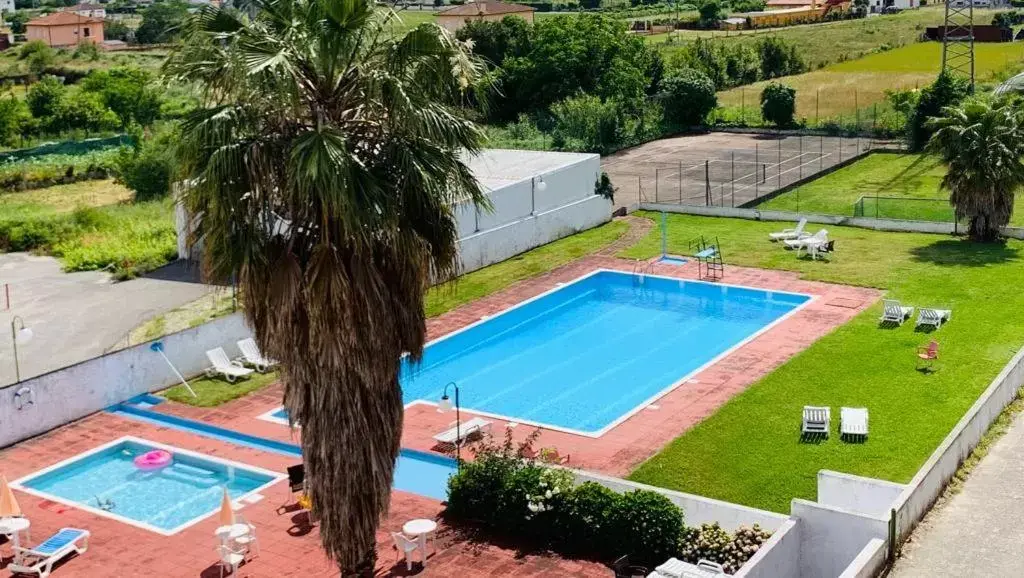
[444,430,768,572]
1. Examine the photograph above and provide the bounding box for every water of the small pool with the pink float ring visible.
[19,441,273,532]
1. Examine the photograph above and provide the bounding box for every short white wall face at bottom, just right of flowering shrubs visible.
[792,499,889,578]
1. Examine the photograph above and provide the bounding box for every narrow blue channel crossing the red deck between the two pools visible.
[110,404,456,500]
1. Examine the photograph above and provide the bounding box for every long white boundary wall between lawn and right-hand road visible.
[893,349,1024,543]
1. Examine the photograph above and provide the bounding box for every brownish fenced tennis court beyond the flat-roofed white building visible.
[601,132,887,207]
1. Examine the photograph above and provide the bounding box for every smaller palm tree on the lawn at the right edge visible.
[928,98,1024,241]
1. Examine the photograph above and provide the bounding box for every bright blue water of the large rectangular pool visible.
[401,272,810,434]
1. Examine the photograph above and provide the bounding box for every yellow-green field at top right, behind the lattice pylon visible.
[718,42,1024,126]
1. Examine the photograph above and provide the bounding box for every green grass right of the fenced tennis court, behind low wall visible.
[758,153,1024,225]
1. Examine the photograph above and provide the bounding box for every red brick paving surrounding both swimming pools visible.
[0,256,881,578]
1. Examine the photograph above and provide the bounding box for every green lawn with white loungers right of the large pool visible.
[624,215,1024,512]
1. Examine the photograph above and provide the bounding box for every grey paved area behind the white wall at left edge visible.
[0,253,213,384]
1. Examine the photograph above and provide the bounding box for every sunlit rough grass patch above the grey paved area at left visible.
[0,179,177,279]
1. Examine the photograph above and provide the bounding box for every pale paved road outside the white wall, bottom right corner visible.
[890,407,1024,578]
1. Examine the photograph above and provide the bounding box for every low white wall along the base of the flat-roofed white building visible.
[459,194,611,273]
